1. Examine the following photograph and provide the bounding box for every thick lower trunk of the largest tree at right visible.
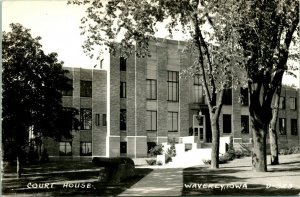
[251,117,267,172]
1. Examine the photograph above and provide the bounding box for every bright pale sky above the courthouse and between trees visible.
[2,0,300,87]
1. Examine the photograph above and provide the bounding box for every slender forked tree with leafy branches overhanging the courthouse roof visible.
[69,0,244,168]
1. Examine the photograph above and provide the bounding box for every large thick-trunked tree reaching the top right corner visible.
[227,0,299,171]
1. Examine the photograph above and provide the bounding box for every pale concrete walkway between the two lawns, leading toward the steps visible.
[119,168,183,196]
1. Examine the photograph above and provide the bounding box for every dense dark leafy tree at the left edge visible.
[2,24,78,176]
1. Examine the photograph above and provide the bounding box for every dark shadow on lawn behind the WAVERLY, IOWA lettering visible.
[182,167,300,196]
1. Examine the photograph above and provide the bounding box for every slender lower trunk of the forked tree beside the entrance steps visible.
[210,112,220,169]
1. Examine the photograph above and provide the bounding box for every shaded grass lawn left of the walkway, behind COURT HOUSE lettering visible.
[2,161,152,196]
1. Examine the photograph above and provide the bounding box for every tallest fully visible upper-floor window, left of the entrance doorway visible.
[168,71,179,101]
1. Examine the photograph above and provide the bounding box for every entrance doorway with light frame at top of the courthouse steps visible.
[193,114,206,142]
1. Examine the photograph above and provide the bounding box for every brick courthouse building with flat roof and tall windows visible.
[44,40,300,158]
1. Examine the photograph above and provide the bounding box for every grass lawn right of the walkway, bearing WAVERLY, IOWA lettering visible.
[182,154,300,196]
